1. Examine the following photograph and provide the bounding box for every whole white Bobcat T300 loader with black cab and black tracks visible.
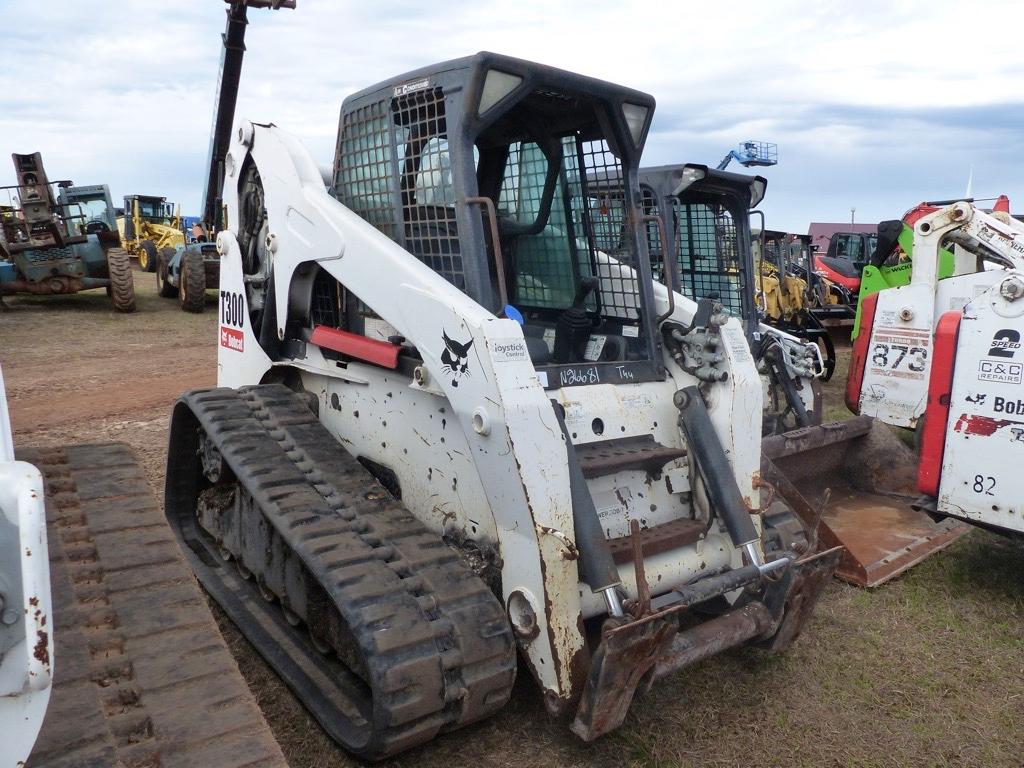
[166,53,840,759]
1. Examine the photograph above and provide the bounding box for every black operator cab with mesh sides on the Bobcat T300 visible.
[332,52,664,386]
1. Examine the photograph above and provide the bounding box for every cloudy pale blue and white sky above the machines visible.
[0,0,1024,231]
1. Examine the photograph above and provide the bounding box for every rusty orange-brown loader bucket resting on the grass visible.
[761,416,970,587]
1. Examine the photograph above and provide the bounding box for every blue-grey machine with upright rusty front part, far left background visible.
[0,152,135,312]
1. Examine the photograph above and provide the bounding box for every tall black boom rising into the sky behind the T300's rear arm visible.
[203,0,295,233]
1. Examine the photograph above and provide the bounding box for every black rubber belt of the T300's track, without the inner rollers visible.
[168,385,516,759]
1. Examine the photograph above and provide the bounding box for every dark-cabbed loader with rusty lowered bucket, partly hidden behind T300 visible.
[640,164,966,587]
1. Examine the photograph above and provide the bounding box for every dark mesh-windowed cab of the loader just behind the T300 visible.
[640,164,767,334]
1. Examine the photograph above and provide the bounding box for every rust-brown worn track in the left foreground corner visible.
[18,444,287,768]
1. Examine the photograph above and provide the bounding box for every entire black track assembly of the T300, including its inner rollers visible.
[167,385,515,759]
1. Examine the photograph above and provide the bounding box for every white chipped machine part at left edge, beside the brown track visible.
[0,370,53,766]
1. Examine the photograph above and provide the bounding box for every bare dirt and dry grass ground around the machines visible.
[0,271,1024,768]
